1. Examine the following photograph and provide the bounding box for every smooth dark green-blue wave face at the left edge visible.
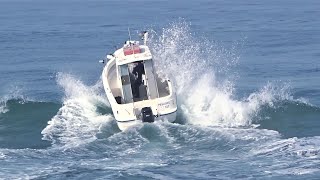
[0,99,61,149]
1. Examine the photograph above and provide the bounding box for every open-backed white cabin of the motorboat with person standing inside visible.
[115,41,170,104]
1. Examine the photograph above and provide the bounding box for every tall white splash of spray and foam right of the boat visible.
[150,22,291,127]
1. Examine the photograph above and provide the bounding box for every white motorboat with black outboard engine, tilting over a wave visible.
[102,32,177,131]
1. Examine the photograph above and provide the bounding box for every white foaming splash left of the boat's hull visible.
[42,73,113,147]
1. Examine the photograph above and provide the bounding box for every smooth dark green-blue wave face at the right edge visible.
[256,100,320,138]
